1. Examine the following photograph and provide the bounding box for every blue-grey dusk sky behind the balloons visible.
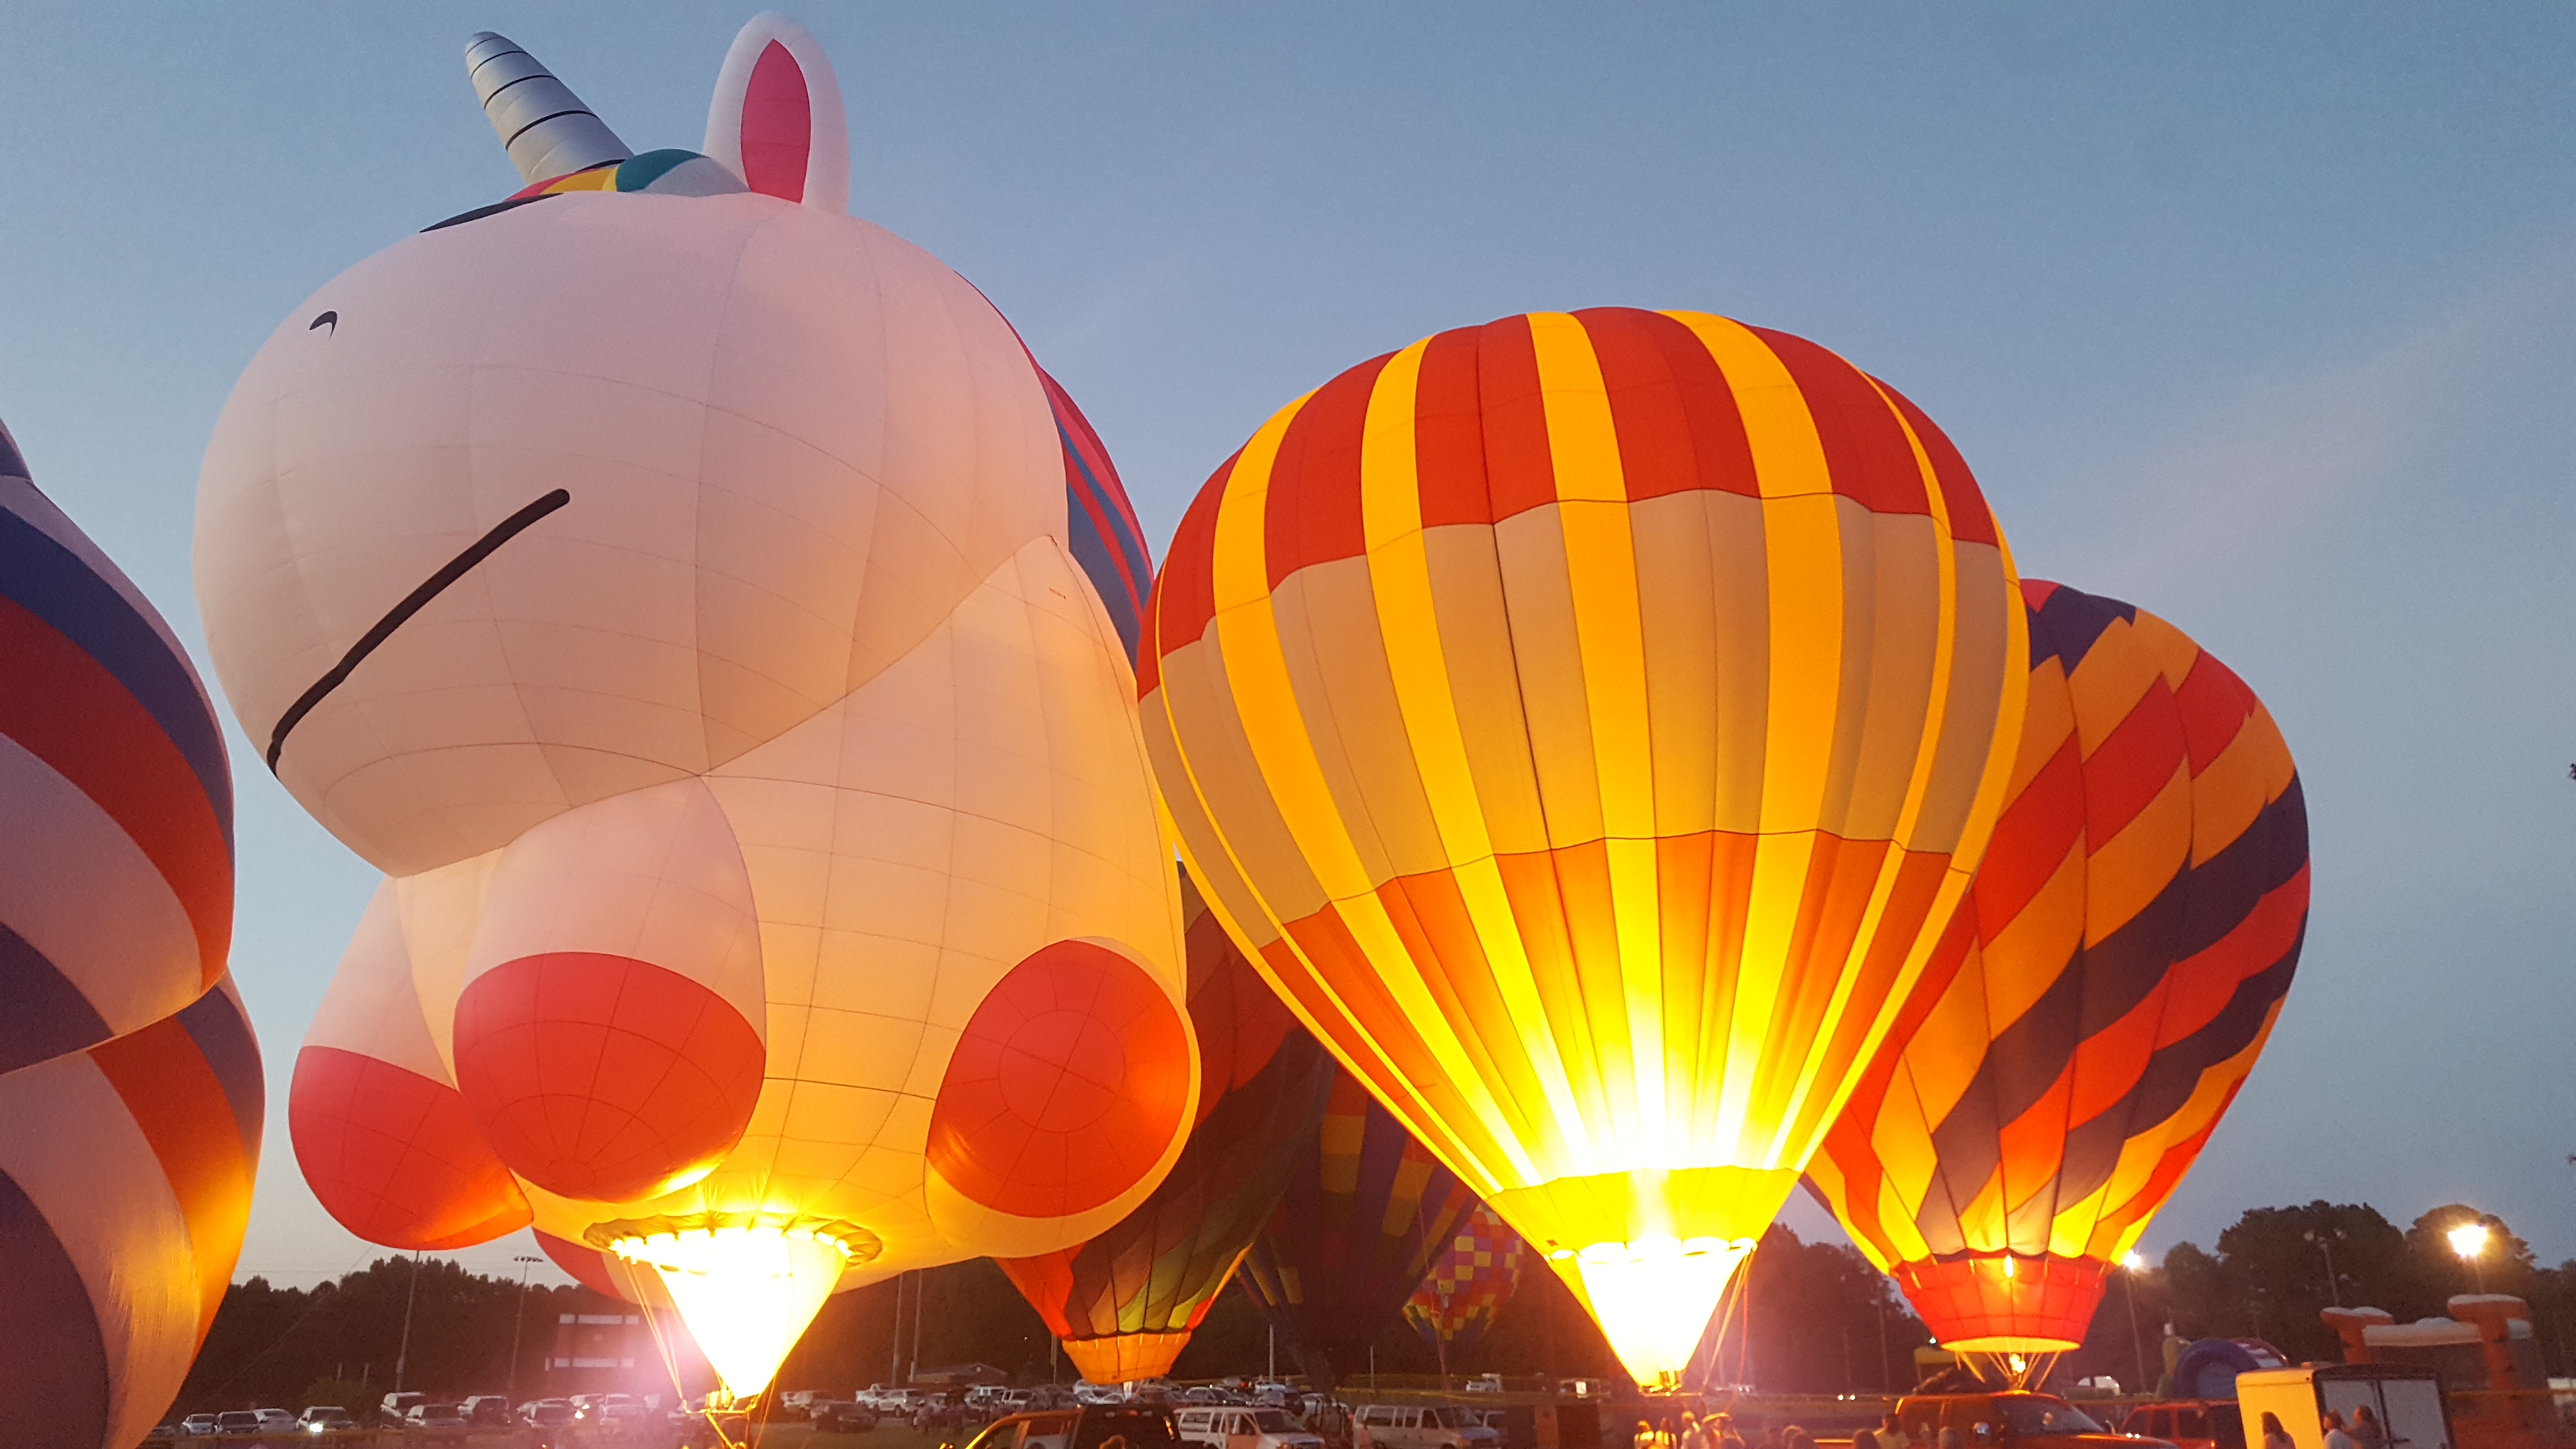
[0,2,2576,1282]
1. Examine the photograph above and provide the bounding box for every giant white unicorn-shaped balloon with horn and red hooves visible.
[196,16,1198,1392]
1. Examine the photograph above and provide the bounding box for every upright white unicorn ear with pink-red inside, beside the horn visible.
[701,10,850,212]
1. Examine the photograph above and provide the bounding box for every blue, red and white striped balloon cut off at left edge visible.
[0,417,263,1449]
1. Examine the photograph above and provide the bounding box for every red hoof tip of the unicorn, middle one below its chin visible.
[456,951,768,1201]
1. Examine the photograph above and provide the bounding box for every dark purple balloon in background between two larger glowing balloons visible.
[1241,1073,1476,1392]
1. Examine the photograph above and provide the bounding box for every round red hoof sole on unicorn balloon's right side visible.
[925,941,1190,1217]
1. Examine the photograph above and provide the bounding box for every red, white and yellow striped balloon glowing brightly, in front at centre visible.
[1139,309,2027,1380]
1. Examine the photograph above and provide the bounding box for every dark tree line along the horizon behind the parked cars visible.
[178,1201,2576,1413]
